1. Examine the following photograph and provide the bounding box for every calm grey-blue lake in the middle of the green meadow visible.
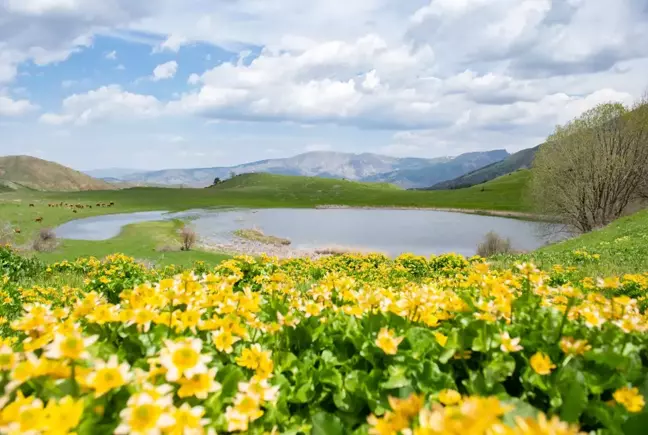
[56,209,547,256]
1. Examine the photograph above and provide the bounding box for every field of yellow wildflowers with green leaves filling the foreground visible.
[0,244,648,435]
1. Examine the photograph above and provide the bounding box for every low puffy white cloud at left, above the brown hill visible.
[40,85,164,125]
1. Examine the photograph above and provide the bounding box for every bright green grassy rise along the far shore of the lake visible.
[41,171,530,211]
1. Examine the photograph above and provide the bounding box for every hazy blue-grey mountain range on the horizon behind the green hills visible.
[116,150,509,187]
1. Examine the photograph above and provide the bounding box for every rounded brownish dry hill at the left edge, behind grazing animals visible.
[0,156,115,191]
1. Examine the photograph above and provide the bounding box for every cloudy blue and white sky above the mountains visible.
[0,0,648,170]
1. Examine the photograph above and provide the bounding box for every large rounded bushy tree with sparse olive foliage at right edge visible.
[531,95,648,232]
